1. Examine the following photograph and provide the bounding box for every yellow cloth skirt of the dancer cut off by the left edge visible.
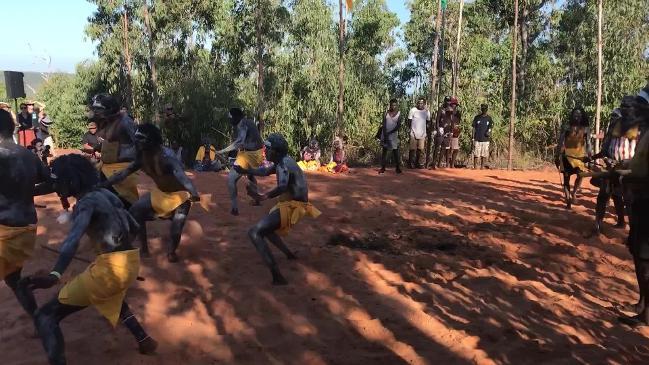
[0,224,36,279]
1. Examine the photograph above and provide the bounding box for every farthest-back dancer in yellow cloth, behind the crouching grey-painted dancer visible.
[218,108,264,215]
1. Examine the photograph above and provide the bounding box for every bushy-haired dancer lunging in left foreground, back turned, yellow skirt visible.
[19,155,157,365]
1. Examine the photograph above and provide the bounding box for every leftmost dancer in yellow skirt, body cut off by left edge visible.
[0,110,50,316]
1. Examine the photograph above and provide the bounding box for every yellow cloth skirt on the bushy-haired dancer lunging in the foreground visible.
[59,249,140,326]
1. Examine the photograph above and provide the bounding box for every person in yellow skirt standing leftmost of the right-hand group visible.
[555,107,592,209]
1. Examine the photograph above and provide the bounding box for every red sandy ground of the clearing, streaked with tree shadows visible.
[0,169,649,365]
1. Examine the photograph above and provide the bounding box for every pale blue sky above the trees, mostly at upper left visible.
[0,0,409,72]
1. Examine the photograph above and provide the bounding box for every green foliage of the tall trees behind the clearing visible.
[30,0,649,168]
